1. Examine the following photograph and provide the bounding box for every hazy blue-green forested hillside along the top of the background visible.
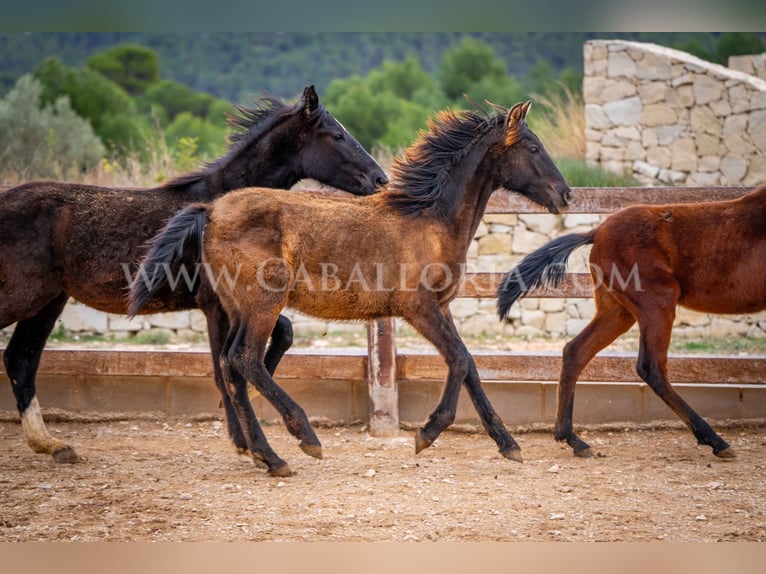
[0,32,732,102]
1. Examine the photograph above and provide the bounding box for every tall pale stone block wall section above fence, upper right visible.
[583,40,766,186]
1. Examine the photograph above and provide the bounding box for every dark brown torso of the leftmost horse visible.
[0,181,201,313]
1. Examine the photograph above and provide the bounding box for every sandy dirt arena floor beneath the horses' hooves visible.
[0,416,766,542]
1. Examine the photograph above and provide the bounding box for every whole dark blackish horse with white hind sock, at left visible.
[0,86,388,462]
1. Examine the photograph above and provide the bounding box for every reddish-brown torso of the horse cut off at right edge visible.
[591,188,766,314]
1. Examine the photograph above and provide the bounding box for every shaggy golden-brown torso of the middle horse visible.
[204,188,461,320]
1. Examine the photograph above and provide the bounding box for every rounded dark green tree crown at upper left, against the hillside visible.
[88,44,159,96]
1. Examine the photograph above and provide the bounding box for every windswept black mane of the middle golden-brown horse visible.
[386,108,507,217]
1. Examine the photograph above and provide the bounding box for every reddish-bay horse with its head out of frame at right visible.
[498,186,766,458]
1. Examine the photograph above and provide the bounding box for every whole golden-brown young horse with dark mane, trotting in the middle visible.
[130,102,571,476]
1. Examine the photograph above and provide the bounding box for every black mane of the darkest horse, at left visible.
[162,94,308,189]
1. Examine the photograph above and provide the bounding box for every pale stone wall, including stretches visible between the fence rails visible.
[6,40,766,346]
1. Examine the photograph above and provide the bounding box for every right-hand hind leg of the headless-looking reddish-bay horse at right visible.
[636,295,735,458]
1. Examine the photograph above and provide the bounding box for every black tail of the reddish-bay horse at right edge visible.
[497,232,594,320]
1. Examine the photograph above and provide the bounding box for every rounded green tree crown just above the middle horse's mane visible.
[437,36,507,102]
